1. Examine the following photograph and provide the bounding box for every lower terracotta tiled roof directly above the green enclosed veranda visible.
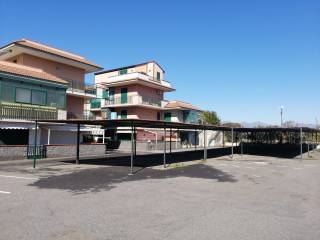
[0,60,68,84]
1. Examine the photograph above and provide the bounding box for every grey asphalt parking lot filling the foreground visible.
[0,151,320,240]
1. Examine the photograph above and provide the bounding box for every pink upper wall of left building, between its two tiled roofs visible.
[12,54,85,82]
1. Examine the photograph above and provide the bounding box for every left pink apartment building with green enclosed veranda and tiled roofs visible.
[0,39,102,144]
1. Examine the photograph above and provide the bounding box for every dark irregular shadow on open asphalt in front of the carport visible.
[29,164,237,194]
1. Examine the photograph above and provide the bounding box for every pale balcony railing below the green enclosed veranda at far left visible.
[0,103,58,120]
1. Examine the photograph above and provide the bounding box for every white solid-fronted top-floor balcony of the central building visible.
[96,72,174,92]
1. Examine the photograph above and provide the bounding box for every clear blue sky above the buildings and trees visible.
[0,0,320,124]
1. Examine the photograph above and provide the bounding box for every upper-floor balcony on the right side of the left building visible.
[66,79,97,98]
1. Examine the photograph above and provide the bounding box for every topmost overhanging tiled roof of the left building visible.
[0,38,102,69]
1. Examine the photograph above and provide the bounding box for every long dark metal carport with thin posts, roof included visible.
[33,119,319,174]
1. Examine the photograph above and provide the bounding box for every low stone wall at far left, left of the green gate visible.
[0,145,27,161]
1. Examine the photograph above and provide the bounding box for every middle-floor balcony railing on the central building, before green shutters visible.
[105,95,161,107]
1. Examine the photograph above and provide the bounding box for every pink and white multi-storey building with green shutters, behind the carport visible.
[85,61,201,140]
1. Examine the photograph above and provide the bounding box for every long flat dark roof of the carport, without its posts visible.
[37,119,320,132]
